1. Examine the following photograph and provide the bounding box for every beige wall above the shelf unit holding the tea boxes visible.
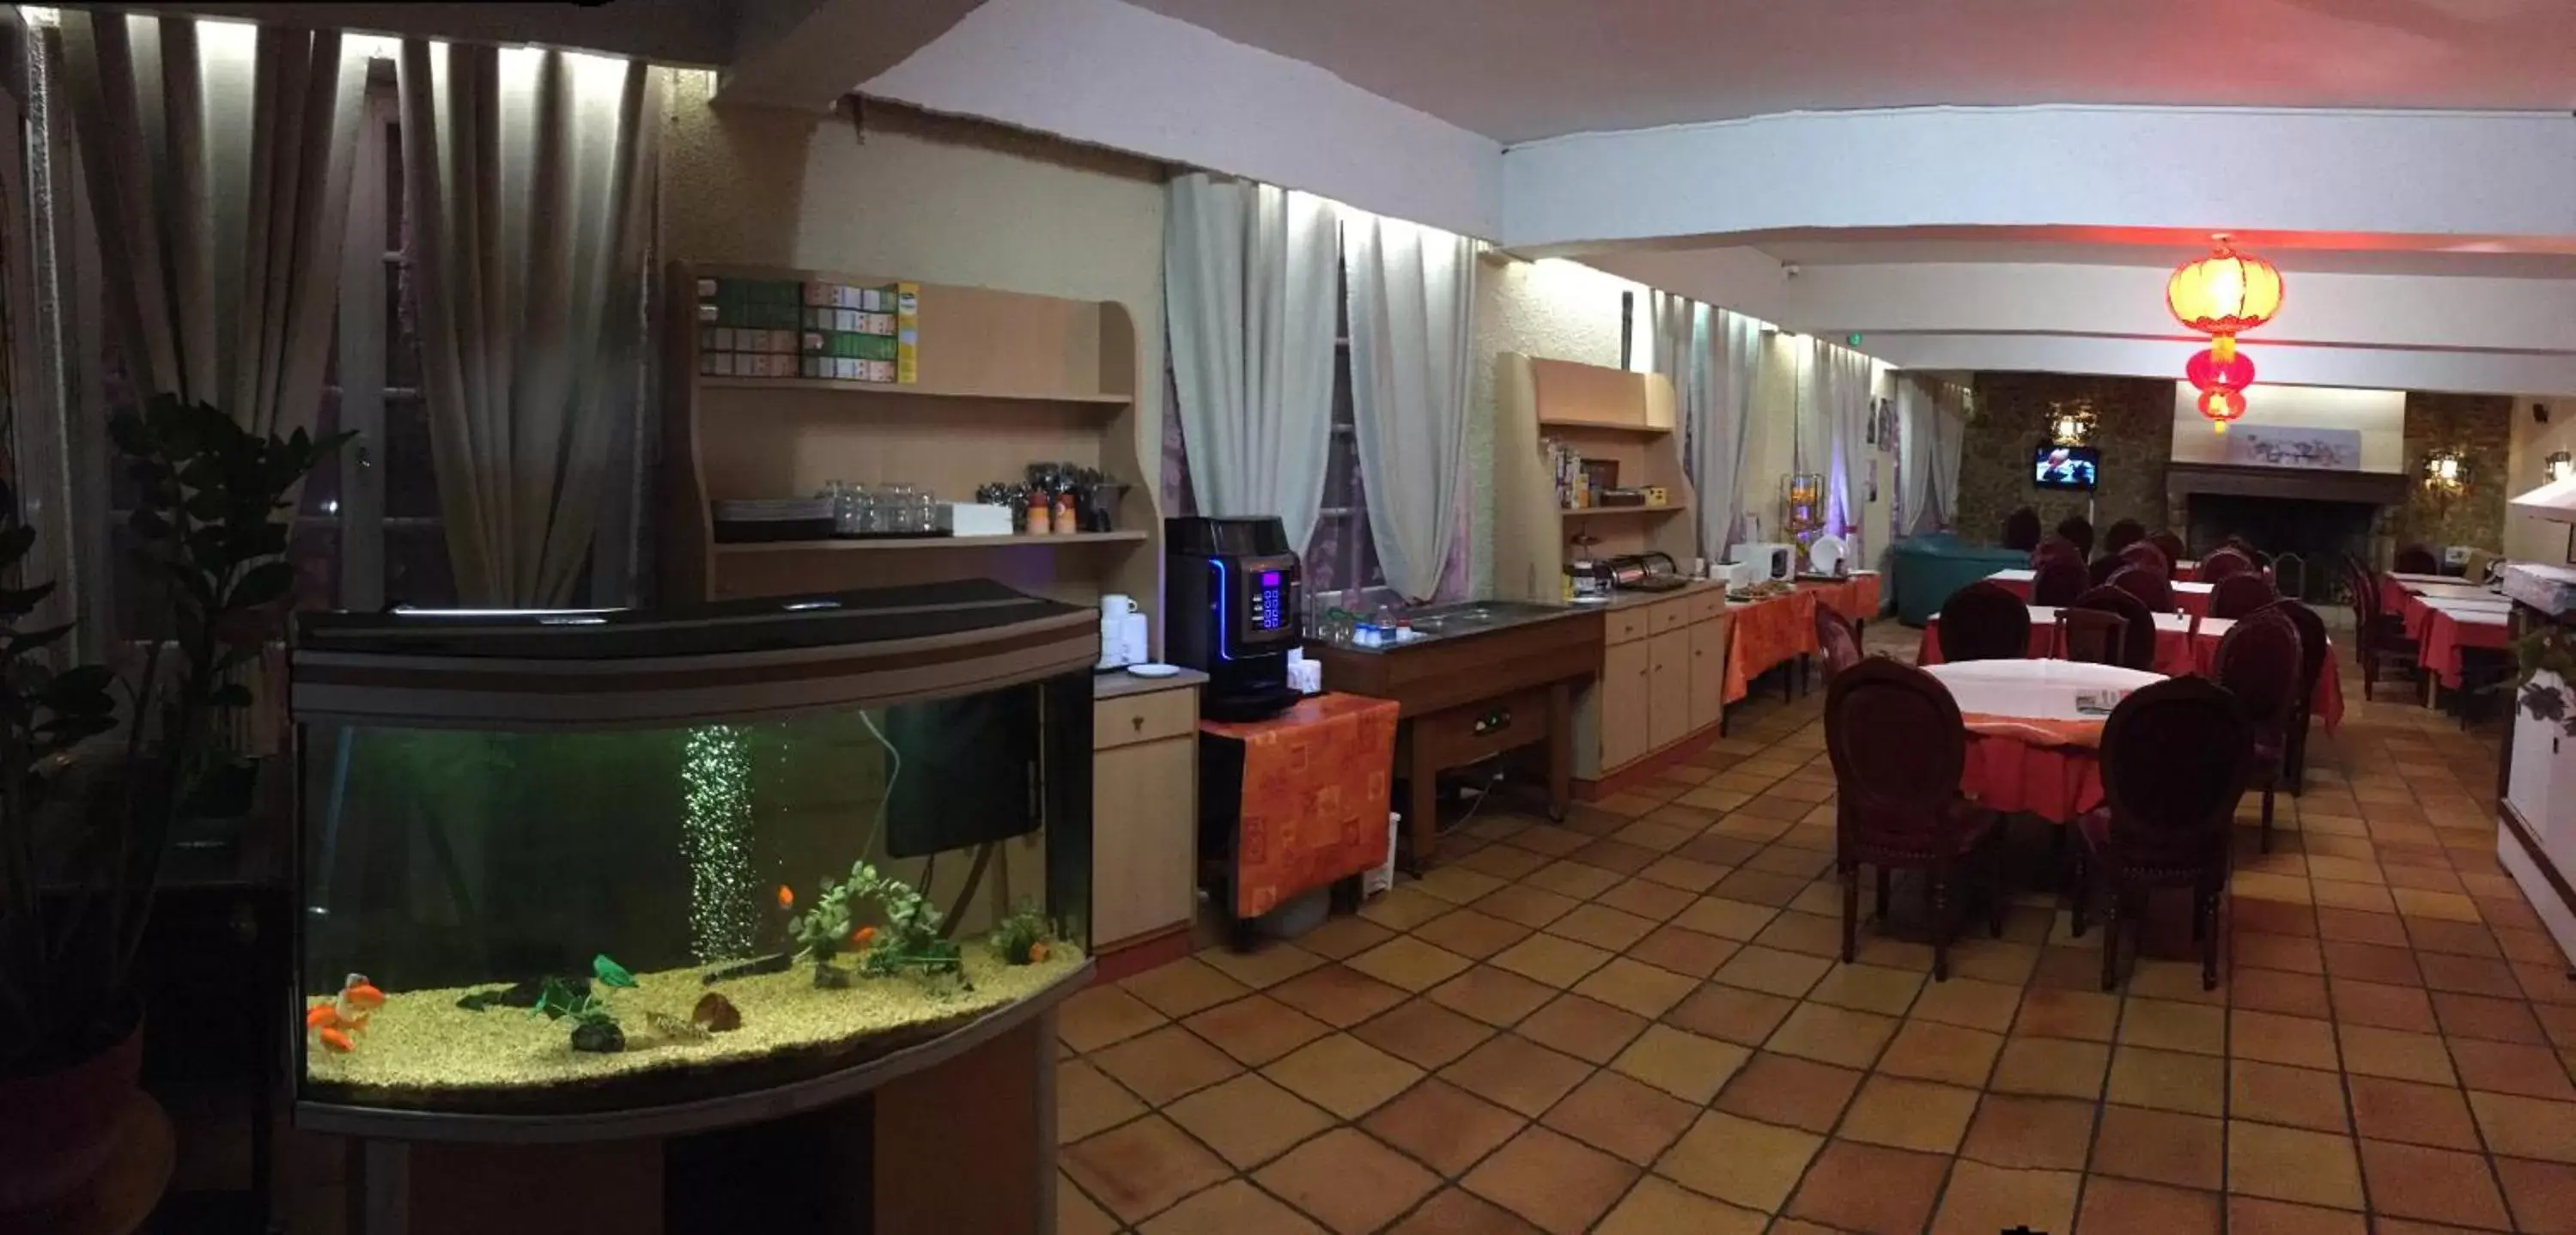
[662,70,1164,484]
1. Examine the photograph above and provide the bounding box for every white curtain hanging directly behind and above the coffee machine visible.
[1162,173,1340,551]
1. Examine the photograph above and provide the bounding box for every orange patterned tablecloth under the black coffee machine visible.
[1198,694,1399,918]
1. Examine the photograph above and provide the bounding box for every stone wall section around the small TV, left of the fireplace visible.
[1950,374,2184,544]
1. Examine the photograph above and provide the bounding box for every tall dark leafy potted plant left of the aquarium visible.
[0,397,345,1212]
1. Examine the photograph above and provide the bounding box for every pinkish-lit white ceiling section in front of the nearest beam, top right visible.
[1131,0,2576,142]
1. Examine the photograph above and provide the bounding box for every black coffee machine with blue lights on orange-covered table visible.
[1162,515,1303,720]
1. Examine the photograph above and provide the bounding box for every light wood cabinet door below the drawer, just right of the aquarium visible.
[1092,735,1198,946]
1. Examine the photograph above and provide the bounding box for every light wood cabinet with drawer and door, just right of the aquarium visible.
[1092,686,1198,952]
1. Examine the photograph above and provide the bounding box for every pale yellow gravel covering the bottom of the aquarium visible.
[307,941,1082,1096]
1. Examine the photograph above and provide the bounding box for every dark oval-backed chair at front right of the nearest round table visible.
[2071,676,2254,990]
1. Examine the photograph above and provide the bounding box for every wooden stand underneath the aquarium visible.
[348,967,1090,1235]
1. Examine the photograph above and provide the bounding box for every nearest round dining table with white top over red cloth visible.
[1924,660,2164,823]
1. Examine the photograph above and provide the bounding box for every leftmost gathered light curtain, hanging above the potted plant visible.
[62,8,366,433]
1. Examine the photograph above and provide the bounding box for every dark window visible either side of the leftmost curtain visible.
[85,59,456,640]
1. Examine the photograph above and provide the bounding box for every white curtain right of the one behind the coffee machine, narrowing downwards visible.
[1342,216,1479,600]
